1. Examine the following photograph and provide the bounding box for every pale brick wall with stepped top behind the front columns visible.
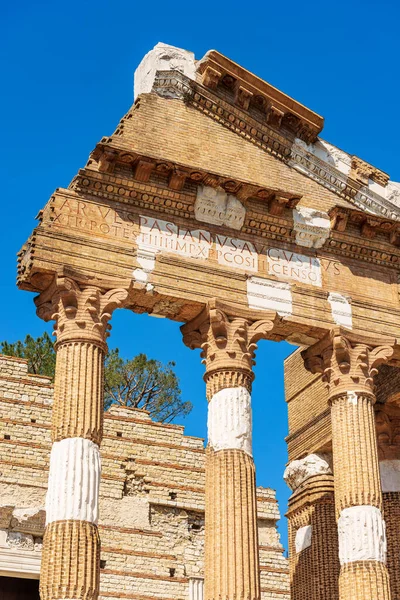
[0,357,289,600]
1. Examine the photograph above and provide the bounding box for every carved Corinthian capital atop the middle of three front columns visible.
[181,299,279,392]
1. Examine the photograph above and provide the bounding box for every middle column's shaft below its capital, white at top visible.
[205,387,260,599]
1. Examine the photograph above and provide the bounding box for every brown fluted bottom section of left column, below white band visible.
[40,521,100,600]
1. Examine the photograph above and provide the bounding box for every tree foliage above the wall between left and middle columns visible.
[104,349,192,423]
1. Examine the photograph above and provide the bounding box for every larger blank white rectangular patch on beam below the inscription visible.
[247,276,293,316]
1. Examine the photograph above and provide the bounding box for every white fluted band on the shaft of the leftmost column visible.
[46,438,101,524]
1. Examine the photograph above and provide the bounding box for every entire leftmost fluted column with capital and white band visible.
[36,277,127,600]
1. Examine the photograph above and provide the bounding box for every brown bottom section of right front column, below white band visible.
[339,560,391,600]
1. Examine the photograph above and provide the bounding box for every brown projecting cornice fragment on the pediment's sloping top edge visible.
[197,50,324,144]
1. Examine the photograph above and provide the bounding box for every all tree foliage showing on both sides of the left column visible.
[0,332,192,423]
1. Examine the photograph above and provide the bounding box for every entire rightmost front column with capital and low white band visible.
[303,328,395,600]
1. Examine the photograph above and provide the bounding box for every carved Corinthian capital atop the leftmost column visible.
[35,277,128,349]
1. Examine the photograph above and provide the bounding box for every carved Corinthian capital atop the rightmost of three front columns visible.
[302,327,395,399]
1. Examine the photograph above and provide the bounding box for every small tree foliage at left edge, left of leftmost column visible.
[0,332,56,379]
